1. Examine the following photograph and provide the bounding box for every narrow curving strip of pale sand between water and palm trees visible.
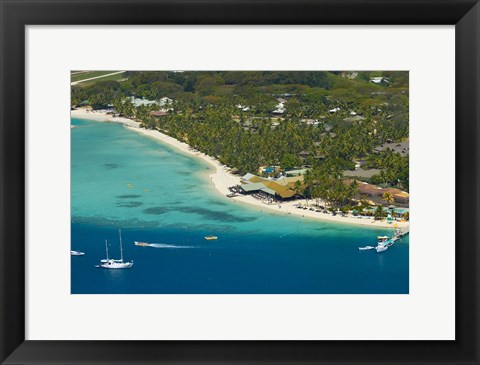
[70,109,409,229]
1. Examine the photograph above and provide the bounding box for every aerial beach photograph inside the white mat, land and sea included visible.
[70,70,410,294]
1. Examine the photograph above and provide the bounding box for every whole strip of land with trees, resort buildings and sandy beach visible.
[72,71,409,225]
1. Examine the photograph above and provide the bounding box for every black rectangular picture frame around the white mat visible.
[0,0,480,364]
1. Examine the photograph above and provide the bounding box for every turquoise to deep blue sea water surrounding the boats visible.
[71,119,409,294]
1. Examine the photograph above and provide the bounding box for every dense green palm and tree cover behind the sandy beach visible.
[71,71,408,206]
